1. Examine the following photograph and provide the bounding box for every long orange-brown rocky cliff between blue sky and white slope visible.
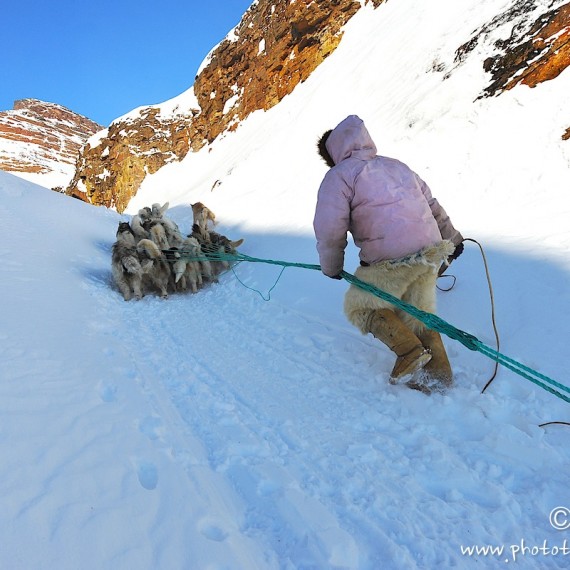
[67,0,384,212]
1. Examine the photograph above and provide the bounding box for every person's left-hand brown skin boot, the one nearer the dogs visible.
[367,309,431,384]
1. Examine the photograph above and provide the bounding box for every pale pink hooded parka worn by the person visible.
[313,115,463,277]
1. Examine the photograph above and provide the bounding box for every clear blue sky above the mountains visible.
[0,0,253,126]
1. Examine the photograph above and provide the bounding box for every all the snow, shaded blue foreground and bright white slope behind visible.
[0,0,570,570]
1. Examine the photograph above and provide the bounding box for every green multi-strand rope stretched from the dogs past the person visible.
[173,250,570,403]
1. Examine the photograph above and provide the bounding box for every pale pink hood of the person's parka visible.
[326,115,376,164]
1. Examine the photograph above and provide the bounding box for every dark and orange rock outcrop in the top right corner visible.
[456,0,570,96]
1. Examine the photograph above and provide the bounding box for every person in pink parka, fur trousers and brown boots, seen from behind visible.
[313,115,463,393]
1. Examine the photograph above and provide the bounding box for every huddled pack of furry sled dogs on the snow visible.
[111,202,243,301]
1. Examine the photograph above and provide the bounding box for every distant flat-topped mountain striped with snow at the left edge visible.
[0,99,103,183]
